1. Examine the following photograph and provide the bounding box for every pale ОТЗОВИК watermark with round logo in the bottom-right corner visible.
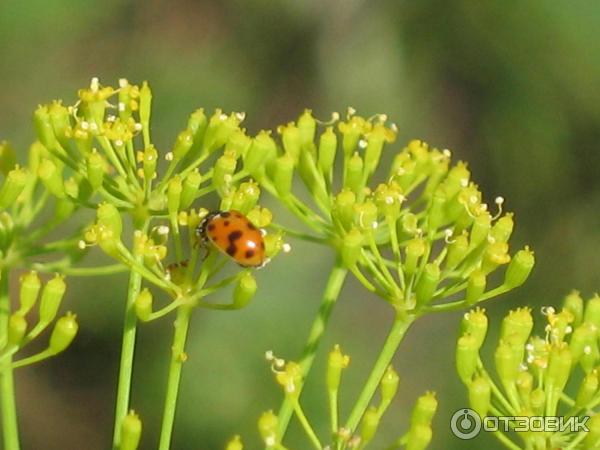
[450,408,589,440]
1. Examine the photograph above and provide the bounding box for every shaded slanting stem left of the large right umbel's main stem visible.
[278,260,348,442]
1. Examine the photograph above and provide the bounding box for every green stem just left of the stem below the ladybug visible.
[113,225,146,450]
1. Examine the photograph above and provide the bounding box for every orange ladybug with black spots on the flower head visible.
[196,210,266,267]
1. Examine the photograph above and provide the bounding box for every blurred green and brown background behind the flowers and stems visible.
[0,0,600,450]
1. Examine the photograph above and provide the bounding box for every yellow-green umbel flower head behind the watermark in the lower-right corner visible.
[456,291,600,450]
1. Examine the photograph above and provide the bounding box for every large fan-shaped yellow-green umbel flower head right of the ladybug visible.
[244,109,534,314]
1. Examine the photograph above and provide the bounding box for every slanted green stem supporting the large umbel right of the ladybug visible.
[346,314,415,433]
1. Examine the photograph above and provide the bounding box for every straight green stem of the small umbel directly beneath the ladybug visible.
[158,305,192,450]
